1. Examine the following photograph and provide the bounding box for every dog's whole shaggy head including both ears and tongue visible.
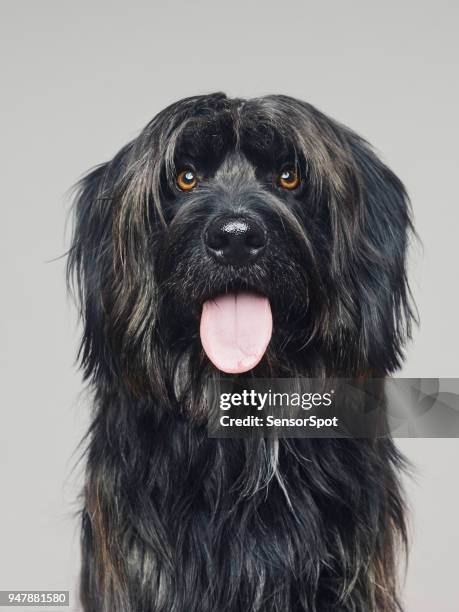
[69,94,412,393]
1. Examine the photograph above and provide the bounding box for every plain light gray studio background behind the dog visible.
[0,0,459,612]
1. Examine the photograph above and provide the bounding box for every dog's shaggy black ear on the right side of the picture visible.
[329,126,414,375]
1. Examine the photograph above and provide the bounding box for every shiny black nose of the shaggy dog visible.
[204,217,266,266]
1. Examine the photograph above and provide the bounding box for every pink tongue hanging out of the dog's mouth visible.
[200,293,273,374]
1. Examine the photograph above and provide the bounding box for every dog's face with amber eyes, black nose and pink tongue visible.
[160,104,330,373]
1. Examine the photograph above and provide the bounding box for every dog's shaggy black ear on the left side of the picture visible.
[67,135,167,389]
